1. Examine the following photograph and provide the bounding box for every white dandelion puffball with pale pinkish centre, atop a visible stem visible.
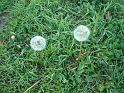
[74,25,90,41]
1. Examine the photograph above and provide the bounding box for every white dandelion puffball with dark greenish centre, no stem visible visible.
[30,36,46,51]
